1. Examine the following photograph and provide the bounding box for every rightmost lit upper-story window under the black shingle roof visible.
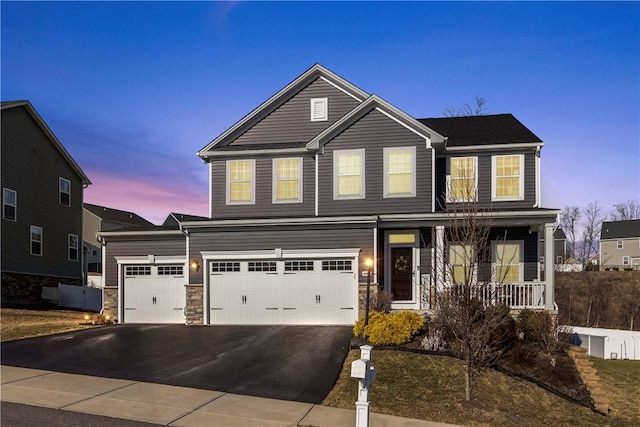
[491,154,524,200]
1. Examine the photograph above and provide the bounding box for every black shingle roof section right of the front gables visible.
[418,114,544,148]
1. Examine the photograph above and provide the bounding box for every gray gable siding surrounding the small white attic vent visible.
[232,78,359,145]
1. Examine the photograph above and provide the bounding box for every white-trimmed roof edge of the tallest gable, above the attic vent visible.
[197,64,369,159]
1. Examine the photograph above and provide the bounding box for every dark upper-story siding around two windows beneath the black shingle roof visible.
[436,151,536,210]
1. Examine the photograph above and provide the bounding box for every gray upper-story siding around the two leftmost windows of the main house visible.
[211,155,316,219]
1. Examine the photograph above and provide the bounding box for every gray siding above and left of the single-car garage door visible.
[103,235,187,286]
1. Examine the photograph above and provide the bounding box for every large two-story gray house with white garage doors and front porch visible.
[100,65,559,325]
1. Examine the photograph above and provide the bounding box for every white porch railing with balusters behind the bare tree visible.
[421,282,546,309]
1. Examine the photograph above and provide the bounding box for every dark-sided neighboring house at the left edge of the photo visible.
[1,101,91,304]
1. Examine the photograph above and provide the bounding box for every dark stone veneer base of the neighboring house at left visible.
[1,272,82,305]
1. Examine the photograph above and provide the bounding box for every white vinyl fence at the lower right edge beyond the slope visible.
[568,326,640,360]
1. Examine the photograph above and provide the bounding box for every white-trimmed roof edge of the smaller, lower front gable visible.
[307,95,444,150]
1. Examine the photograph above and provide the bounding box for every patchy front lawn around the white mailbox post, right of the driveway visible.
[323,350,640,427]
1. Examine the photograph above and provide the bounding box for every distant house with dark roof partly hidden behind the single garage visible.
[82,203,153,280]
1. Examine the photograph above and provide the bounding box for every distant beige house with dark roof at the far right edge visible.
[600,219,640,270]
